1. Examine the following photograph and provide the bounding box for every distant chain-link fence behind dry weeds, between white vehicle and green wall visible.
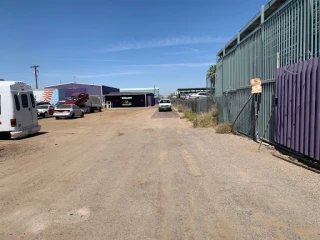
[173,98,215,114]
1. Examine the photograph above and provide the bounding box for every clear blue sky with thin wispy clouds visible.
[0,0,268,94]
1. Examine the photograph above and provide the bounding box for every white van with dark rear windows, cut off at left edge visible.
[0,81,40,139]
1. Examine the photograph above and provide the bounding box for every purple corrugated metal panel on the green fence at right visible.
[275,58,320,160]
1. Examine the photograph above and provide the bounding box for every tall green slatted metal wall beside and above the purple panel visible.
[215,0,320,142]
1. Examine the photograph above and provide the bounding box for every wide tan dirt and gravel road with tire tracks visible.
[0,108,320,240]
